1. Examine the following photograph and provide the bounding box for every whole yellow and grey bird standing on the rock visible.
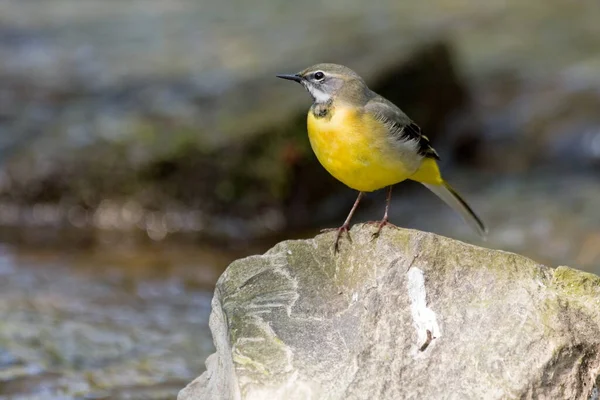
[277,64,487,252]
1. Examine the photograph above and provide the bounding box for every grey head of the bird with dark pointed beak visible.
[277,64,368,103]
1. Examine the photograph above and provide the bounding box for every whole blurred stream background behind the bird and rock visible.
[0,0,600,399]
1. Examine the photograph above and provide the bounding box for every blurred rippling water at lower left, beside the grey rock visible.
[0,241,228,399]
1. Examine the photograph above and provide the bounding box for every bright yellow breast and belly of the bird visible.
[307,107,420,192]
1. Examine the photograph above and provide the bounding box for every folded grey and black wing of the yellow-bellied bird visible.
[365,95,440,160]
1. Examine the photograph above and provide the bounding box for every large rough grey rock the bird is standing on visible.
[178,225,600,400]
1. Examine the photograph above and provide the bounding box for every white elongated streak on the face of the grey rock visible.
[407,267,442,350]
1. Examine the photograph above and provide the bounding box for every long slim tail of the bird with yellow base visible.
[410,158,487,239]
